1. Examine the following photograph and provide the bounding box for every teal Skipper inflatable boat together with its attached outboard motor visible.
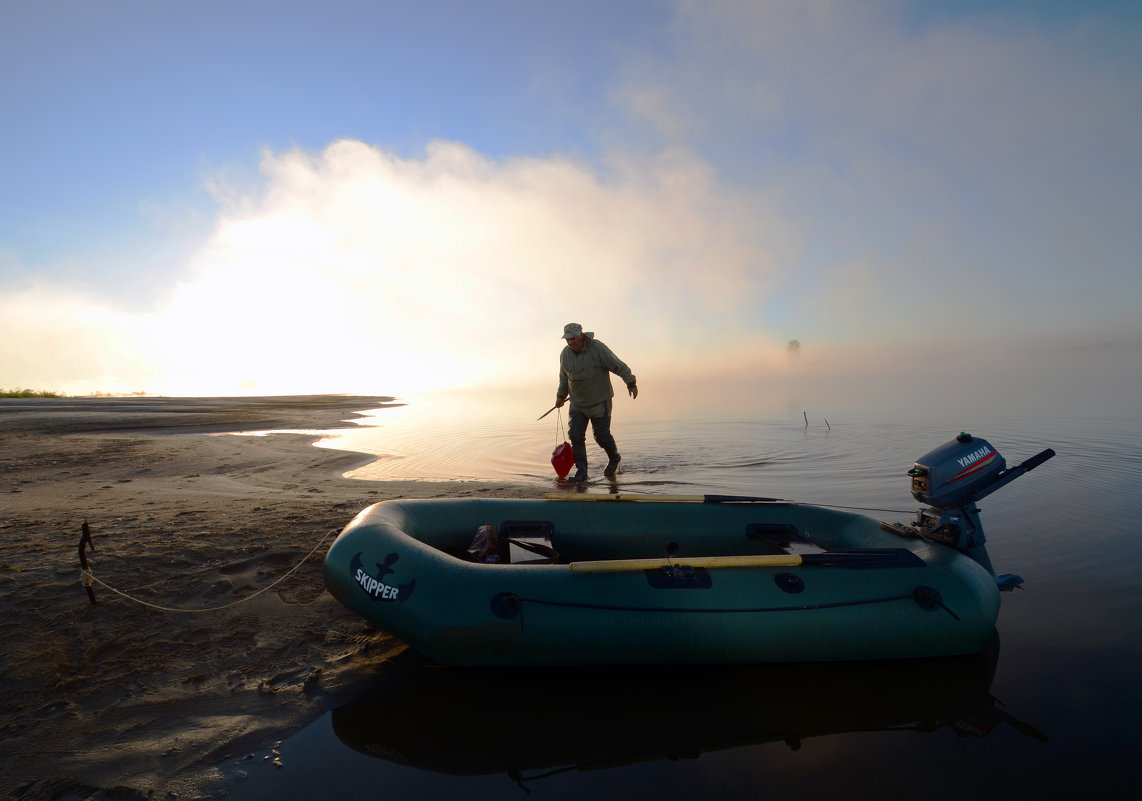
[324,434,1053,666]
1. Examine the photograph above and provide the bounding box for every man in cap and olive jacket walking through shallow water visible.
[555,322,638,482]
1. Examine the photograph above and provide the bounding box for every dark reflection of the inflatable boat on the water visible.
[332,634,1046,784]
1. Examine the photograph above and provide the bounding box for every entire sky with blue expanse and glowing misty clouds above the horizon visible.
[0,0,1142,419]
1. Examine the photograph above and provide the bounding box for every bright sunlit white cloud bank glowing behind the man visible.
[2,141,799,393]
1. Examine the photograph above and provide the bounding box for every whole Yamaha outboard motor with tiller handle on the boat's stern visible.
[908,433,1055,590]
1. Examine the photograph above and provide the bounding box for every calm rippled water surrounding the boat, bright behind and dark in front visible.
[218,407,1142,801]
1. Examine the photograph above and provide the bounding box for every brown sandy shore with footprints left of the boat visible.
[0,395,540,799]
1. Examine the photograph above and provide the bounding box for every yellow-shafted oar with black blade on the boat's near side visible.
[570,548,927,572]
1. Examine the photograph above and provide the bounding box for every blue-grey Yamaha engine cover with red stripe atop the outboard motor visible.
[908,433,1007,508]
